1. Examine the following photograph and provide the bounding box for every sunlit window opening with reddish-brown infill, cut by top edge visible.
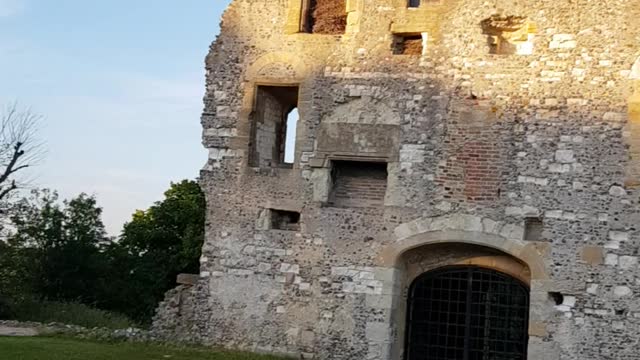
[300,0,347,35]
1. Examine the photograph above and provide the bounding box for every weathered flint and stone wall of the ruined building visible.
[154,0,640,360]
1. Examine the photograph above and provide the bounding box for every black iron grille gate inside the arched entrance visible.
[406,267,529,360]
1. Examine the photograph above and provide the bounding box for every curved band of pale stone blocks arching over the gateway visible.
[378,215,548,280]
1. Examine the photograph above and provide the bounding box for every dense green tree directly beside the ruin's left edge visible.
[108,180,205,322]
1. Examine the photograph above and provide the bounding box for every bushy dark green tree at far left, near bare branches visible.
[8,190,109,304]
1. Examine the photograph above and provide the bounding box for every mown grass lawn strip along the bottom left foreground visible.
[0,337,282,360]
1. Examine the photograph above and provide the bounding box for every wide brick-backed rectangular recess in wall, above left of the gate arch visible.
[329,160,388,207]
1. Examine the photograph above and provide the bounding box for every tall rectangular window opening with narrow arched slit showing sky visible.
[250,86,299,168]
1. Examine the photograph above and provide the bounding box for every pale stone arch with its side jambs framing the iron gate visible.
[377,214,552,358]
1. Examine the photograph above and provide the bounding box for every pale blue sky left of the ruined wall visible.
[0,0,229,235]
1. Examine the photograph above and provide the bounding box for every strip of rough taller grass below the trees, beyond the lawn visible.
[11,300,137,329]
